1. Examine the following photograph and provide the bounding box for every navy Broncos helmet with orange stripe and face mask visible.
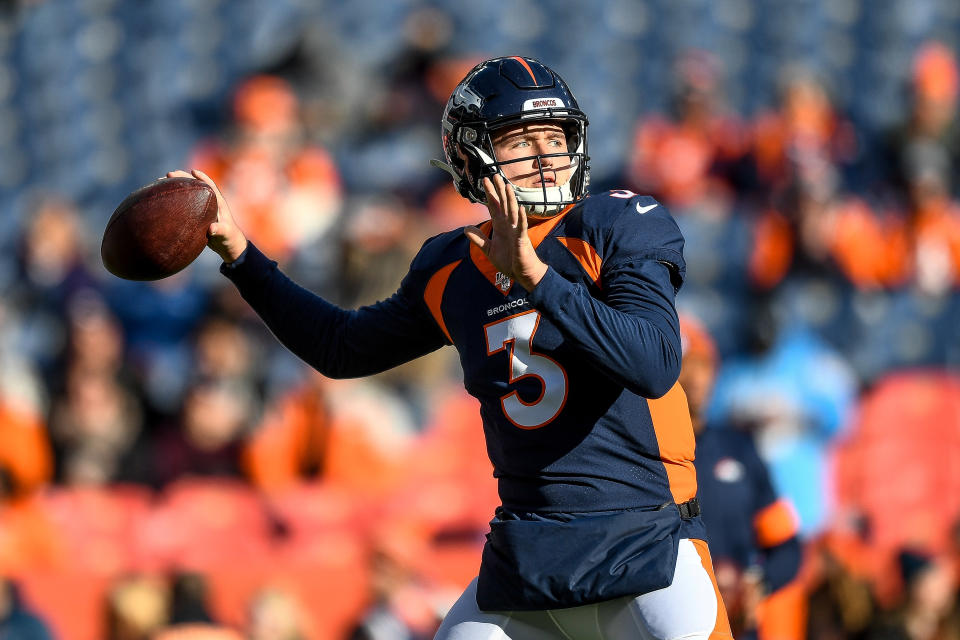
[431,56,590,217]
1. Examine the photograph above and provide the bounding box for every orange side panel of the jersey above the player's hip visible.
[647,382,697,504]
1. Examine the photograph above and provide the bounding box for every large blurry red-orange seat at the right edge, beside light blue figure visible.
[834,370,960,589]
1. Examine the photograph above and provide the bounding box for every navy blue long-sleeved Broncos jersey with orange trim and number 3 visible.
[223,191,705,538]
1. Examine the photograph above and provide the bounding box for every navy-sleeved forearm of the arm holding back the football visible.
[221,245,432,378]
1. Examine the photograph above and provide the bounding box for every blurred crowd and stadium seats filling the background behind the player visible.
[0,0,960,640]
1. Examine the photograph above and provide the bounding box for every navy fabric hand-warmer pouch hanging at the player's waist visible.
[477,505,681,611]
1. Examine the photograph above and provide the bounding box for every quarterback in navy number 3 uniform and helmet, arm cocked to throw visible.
[170,56,730,640]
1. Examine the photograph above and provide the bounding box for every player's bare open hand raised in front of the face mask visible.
[463,175,547,291]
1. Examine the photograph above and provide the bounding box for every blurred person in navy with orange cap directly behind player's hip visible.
[680,315,805,640]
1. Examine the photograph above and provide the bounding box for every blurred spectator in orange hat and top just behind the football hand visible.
[187,75,342,270]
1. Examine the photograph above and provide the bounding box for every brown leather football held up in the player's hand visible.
[100,178,217,280]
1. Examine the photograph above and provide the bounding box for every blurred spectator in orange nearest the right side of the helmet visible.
[627,51,748,213]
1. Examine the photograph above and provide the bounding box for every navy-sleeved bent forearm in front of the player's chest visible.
[529,267,680,398]
